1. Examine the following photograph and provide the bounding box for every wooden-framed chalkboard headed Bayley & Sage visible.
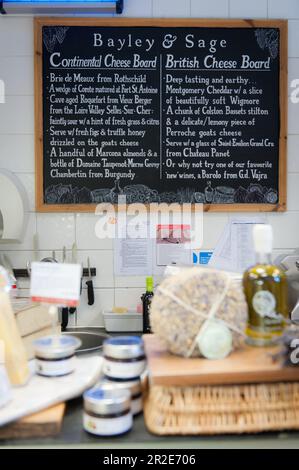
[35,18,287,212]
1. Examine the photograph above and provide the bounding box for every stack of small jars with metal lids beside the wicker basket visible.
[83,336,146,436]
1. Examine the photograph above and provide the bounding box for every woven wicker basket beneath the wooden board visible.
[144,383,299,435]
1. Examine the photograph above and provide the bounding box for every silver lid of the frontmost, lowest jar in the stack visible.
[83,384,131,415]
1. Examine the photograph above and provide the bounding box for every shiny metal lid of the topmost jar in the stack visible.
[103,336,144,360]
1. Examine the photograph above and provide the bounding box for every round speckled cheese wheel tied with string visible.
[150,267,247,357]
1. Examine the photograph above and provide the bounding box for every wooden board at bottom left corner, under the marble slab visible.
[0,403,65,439]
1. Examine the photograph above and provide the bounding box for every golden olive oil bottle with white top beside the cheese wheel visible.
[243,224,288,346]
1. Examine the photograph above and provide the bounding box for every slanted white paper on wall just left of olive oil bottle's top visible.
[209,216,266,273]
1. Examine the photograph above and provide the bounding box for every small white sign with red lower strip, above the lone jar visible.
[30,262,82,307]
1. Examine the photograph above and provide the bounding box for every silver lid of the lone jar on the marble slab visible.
[33,335,81,360]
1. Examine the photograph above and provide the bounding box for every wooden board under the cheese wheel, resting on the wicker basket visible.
[143,335,299,386]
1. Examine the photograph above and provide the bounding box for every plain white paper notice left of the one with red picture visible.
[114,222,152,276]
